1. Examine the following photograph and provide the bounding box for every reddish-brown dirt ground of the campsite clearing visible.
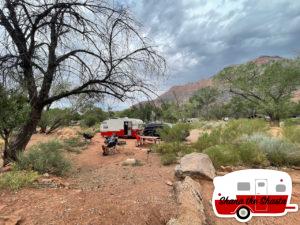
[0,134,300,225]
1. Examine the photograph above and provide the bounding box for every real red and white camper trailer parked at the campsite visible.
[100,117,143,138]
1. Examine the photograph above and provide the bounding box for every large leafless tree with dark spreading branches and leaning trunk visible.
[0,0,165,160]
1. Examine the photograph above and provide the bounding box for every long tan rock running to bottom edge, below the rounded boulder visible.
[167,177,207,225]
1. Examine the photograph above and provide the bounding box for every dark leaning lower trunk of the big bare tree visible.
[4,106,43,161]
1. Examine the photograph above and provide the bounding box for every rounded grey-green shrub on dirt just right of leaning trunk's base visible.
[17,141,71,175]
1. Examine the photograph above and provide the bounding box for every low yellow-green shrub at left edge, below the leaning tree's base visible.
[0,170,39,191]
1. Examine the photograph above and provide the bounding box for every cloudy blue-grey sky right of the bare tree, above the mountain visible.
[106,0,300,109]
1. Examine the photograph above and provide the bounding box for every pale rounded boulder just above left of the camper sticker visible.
[175,153,216,180]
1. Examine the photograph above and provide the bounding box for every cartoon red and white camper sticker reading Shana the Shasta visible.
[212,169,298,222]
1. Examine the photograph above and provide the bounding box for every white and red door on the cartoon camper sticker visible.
[255,179,268,211]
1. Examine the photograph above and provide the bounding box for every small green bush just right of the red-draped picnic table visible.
[159,123,191,142]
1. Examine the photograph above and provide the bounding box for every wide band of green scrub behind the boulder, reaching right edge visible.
[153,119,300,168]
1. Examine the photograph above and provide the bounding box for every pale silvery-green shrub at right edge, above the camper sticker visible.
[242,133,300,166]
